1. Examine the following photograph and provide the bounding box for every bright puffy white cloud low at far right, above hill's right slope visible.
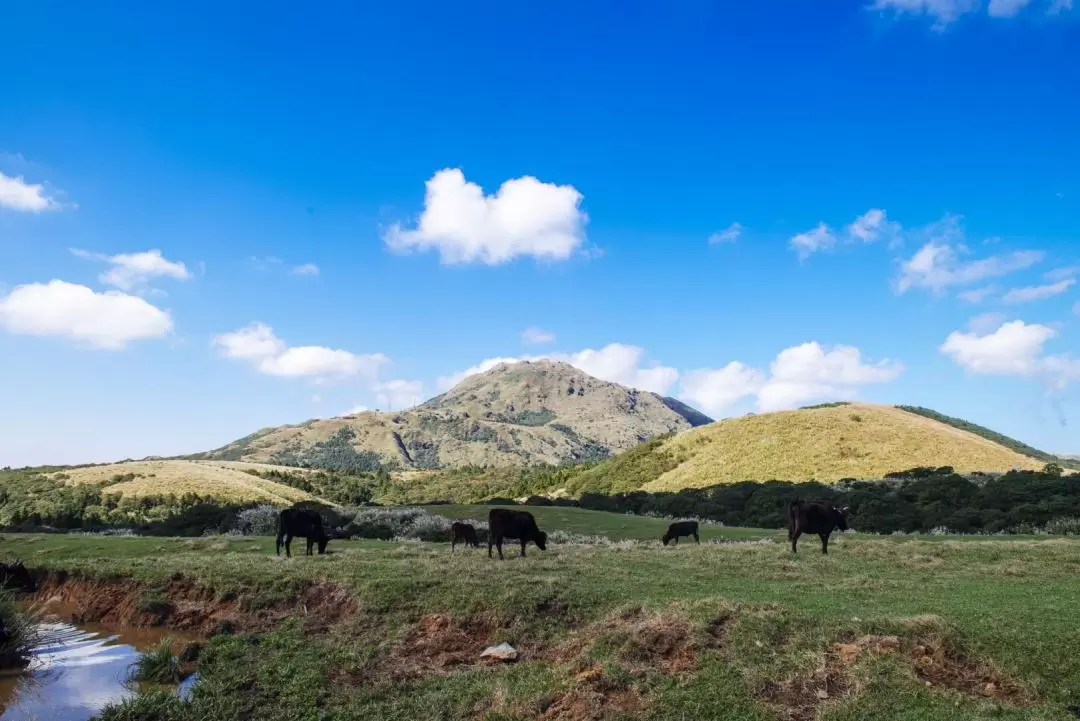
[941,321,1057,376]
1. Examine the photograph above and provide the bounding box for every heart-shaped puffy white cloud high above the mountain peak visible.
[383,168,589,266]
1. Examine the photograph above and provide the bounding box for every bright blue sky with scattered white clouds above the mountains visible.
[0,0,1080,465]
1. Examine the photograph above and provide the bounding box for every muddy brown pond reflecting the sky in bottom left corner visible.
[0,622,194,721]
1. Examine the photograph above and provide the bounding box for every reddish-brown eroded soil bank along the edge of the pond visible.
[31,573,357,636]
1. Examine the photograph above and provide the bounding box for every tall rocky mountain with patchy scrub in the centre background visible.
[195,361,712,471]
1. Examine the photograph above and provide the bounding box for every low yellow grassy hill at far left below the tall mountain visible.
[53,461,319,505]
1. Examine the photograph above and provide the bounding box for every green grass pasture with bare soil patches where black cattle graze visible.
[8,506,1080,721]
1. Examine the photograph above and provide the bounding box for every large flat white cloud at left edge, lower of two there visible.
[0,281,173,351]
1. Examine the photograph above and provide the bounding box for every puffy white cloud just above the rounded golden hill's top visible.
[757,342,904,411]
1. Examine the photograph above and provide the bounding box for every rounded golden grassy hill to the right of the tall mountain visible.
[644,404,1044,491]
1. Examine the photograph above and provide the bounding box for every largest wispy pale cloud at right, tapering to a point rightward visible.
[896,241,1043,293]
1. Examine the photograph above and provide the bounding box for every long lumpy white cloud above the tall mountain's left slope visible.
[211,323,390,381]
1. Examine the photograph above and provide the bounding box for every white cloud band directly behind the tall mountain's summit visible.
[436,343,678,394]
